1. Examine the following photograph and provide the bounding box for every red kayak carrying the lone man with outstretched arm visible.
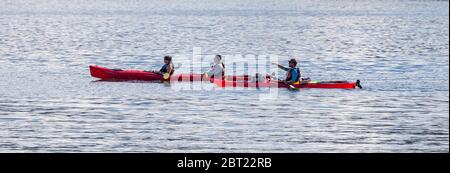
[213,79,362,89]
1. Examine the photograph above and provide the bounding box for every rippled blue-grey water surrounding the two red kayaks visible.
[0,0,449,152]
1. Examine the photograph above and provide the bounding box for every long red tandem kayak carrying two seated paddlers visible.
[89,65,249,81]
